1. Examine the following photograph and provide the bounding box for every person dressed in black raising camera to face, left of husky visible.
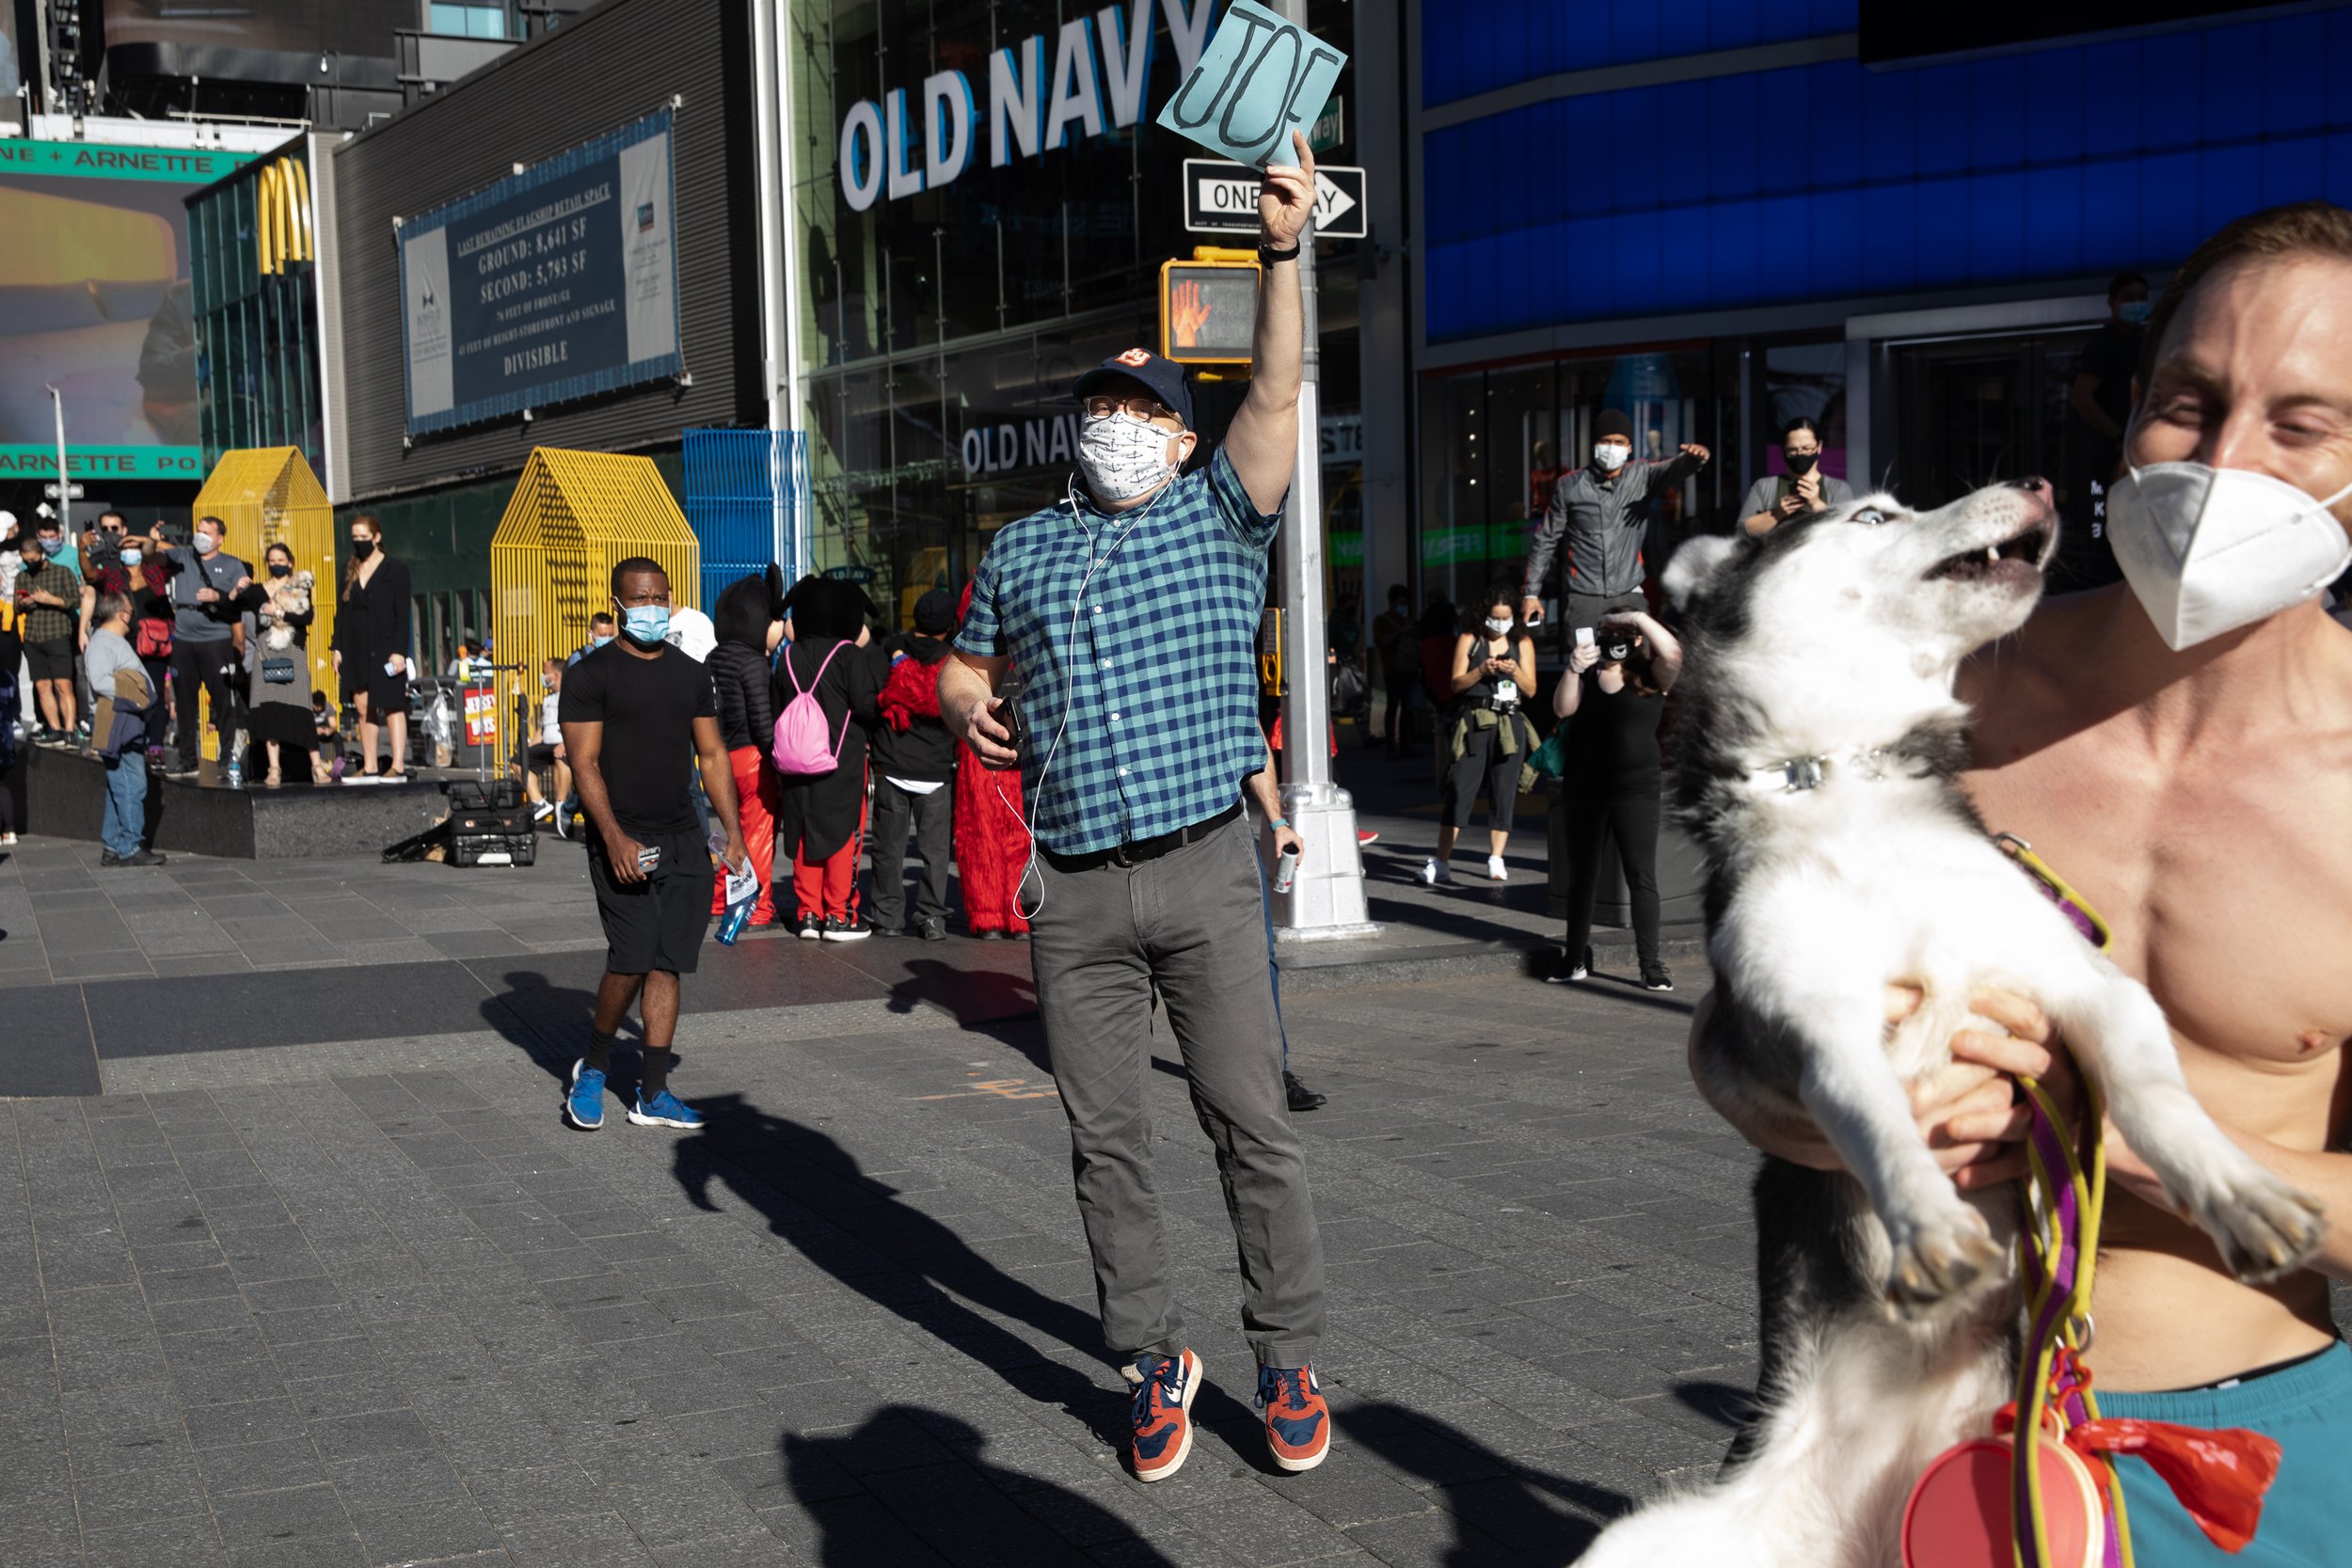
[1550,611,1682,992]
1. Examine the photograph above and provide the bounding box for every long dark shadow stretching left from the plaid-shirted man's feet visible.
[673,1093,1195,1446]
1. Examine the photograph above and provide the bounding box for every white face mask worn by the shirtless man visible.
[2107,433,2352,651]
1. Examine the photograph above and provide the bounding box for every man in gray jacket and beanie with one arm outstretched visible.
[1519,409,1708,626]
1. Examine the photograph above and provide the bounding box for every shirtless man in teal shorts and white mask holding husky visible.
[1693,202,2352,1568]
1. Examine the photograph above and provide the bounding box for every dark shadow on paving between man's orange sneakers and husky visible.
[1331,1399,1632,1568]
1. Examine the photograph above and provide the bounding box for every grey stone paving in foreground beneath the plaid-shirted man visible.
[0,963,1755,1568]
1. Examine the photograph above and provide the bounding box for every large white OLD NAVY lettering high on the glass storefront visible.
[840,0,1216,212]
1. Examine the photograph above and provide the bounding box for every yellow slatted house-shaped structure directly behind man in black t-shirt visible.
[489,447,704,691]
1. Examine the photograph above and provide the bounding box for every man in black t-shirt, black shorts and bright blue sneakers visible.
[555,555,751,1131]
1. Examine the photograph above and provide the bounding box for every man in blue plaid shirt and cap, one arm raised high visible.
[939,131,1331,1481]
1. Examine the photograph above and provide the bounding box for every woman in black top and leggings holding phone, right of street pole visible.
[1421,583,1536,886]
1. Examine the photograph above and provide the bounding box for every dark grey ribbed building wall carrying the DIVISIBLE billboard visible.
[318,0,765,670]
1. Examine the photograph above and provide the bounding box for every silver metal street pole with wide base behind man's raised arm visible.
[1273,0,1378,941]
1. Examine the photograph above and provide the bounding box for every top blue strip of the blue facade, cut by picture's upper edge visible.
[1421,0,1858,108]
